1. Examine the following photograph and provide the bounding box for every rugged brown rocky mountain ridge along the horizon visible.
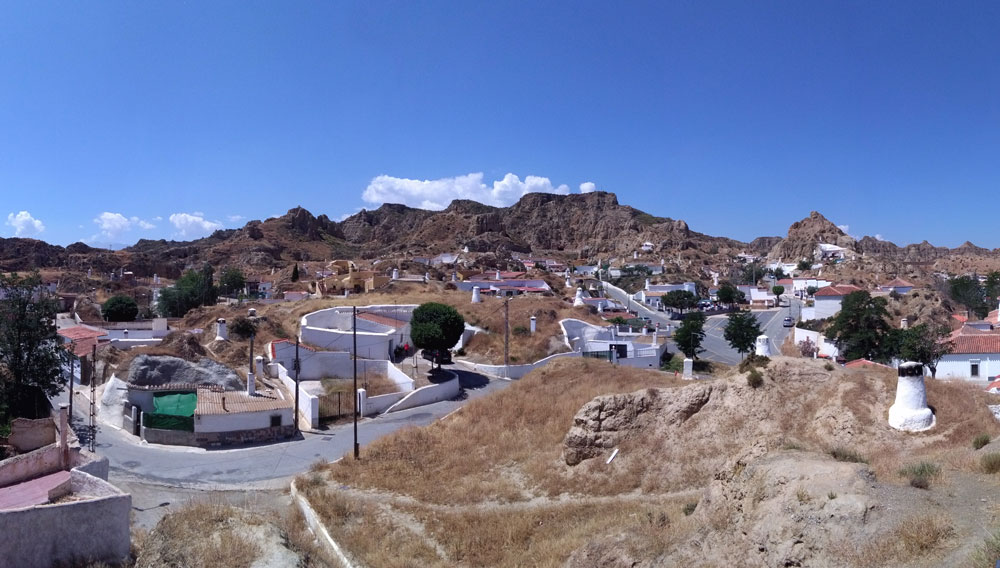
[0,191,1000,278]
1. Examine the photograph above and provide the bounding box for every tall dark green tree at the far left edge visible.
[0,271,63,418]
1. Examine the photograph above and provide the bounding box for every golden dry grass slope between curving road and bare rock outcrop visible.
[330,359,682,503]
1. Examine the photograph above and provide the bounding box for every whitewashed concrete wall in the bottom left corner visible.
[0,471,132,568]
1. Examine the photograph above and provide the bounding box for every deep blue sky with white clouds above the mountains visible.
[0,1,1000,248]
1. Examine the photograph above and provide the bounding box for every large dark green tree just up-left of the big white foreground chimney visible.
[826,290,893,362]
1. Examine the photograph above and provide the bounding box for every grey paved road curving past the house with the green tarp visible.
[53,367,510,489]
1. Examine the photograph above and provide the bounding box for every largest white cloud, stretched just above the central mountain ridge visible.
[361,172,590,210]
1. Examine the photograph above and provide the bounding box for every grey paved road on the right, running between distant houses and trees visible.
[606,286,801,365]
